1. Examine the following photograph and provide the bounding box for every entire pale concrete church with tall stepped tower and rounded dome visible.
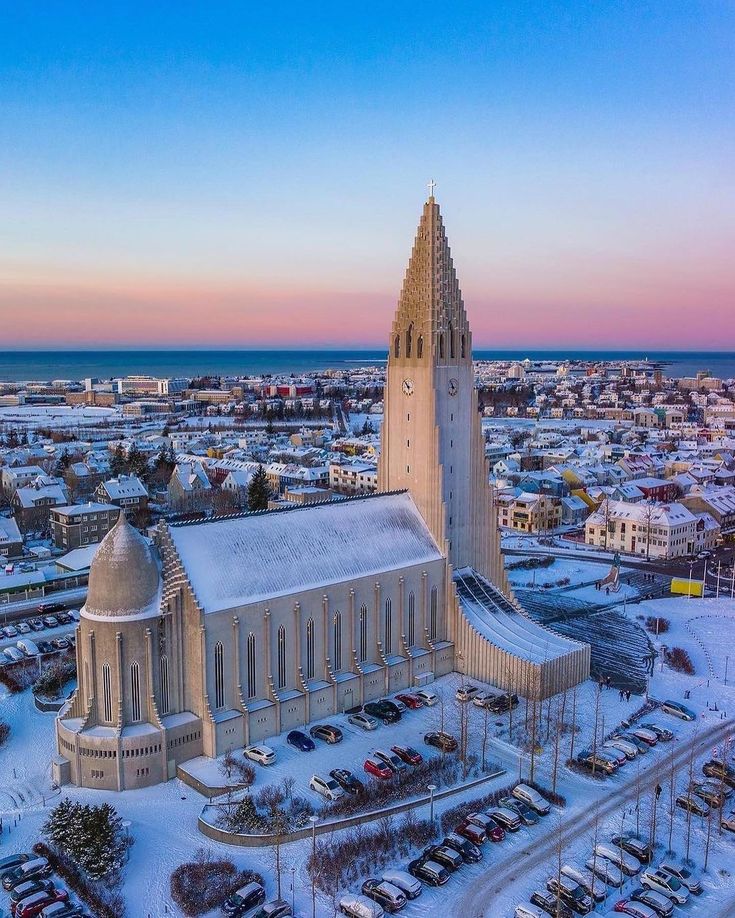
[53,194,590,790]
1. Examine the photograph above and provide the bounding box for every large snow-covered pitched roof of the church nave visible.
[169,492,442,612]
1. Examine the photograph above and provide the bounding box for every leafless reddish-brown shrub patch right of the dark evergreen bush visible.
[171,850,263,915]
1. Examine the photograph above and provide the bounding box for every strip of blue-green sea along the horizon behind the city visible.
[0,349,735,382]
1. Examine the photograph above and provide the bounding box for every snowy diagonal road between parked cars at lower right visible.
[455,720,733,918]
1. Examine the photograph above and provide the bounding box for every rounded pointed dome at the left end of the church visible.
[83,510,161,618]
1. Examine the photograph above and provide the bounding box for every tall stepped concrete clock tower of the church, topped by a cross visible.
[379,194,503,583]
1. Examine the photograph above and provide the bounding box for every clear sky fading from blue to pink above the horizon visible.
[0,0,735,351]
